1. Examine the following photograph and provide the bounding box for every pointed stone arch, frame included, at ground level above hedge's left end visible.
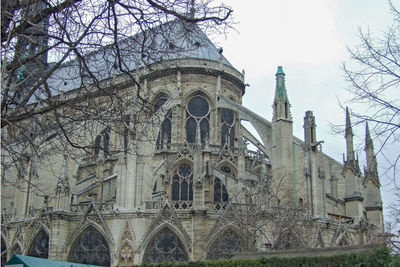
[142,225,190,262]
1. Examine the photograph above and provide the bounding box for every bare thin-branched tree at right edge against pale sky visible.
[343,1,400,254]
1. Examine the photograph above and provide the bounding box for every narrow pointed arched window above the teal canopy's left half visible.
[26,226,50,258]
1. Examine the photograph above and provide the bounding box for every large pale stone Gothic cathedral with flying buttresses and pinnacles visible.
[1,21,384,266]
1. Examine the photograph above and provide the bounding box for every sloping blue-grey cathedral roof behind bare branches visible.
[39,20,232,100]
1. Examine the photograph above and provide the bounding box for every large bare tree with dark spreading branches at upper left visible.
[1,0,232,192]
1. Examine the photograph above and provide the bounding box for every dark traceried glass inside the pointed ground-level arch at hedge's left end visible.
[143,229,188,262]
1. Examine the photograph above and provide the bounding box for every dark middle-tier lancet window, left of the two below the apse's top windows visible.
[172,163,193,209]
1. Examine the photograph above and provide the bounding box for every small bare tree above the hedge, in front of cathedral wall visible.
[209,166,314,257]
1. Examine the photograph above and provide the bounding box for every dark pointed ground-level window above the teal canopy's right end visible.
[69,226,110,266]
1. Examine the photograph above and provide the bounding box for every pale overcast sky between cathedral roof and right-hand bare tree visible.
[213,0,397,219]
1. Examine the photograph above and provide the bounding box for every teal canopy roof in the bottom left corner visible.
[5,254,102,267]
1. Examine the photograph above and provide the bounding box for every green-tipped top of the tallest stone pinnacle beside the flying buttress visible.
[272,66,292,121]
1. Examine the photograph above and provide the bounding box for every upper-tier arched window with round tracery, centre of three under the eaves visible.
[186,94,210,144]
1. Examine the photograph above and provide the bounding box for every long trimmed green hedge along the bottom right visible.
[140,247,400,267]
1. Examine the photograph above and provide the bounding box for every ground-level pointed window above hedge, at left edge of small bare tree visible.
[207,230,244,260]
